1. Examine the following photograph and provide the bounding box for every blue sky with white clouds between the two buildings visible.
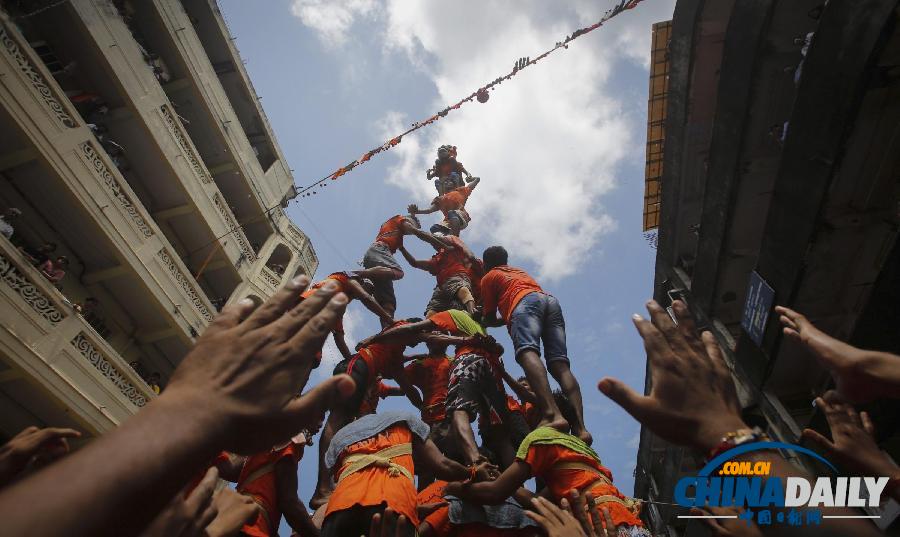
[219,0,674,535]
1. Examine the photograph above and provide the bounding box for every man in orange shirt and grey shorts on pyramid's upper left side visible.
[354,214,443,322]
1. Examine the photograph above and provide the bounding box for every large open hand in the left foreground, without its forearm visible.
[166,276,353,454]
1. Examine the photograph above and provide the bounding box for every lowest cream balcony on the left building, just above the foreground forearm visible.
[0,237,155,435]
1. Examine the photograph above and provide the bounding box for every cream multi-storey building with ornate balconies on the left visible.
[0,0,318,441]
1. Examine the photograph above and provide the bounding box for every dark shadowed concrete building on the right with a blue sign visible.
[635,0,900,536]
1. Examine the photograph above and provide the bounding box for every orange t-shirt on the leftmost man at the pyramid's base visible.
[237,442,302,537]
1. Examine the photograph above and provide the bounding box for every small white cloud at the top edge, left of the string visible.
[291,0,378,47]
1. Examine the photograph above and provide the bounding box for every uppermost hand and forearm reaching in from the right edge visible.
[775,306,900,403]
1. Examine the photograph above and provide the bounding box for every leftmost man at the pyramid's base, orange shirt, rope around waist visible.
[227,431,319,537]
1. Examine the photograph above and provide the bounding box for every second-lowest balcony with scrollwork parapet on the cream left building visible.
[0,15,214,348]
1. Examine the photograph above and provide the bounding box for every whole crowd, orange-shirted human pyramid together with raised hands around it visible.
[0,146,900,537]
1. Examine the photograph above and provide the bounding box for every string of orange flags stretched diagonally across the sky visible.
[296,0,643,200]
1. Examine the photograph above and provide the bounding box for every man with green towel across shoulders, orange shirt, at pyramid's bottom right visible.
[444,392,650,537]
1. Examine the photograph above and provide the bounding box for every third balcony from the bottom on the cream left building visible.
[7,2,255,306]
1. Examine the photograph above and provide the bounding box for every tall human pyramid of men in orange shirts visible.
[274,146,642,536]
